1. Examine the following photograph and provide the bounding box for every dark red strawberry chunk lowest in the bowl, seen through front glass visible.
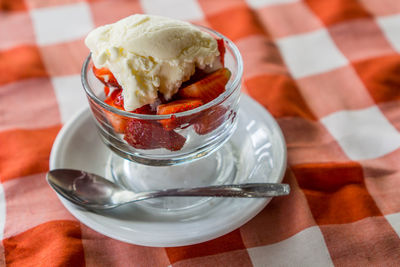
[124,119,186,151]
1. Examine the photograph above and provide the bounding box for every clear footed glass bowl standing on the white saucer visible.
[81,26,243,210]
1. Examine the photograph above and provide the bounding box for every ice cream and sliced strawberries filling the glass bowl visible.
[85,14,231,151]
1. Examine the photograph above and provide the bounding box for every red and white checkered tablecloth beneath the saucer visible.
[0,0,400,266]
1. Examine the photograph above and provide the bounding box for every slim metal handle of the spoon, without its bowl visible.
[137,183,290,200]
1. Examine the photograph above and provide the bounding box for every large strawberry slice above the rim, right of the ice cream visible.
[178,68,231,103]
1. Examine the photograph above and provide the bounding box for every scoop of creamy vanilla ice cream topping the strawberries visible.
[85,14,220,111]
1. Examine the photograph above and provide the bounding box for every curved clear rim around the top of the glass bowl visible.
[81,24,243,120]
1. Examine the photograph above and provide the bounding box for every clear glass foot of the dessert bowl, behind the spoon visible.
[106,142,238,212]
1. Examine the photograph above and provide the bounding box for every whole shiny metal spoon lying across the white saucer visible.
[47,169,290,209]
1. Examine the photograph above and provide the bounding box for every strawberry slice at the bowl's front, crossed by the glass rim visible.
[157,99,203,130]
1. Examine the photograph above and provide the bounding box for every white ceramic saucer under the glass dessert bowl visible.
[50,95,286,247]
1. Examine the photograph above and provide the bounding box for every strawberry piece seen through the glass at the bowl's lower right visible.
[193,106,227,135]
